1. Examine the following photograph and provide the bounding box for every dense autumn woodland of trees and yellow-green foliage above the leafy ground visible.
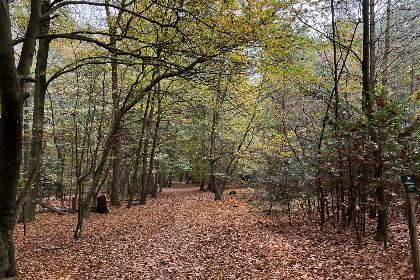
[0,0,420,279]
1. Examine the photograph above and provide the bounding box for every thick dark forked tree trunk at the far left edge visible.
[0,0,42,279]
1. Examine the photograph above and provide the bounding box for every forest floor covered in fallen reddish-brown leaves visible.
[15,183,412,280]
